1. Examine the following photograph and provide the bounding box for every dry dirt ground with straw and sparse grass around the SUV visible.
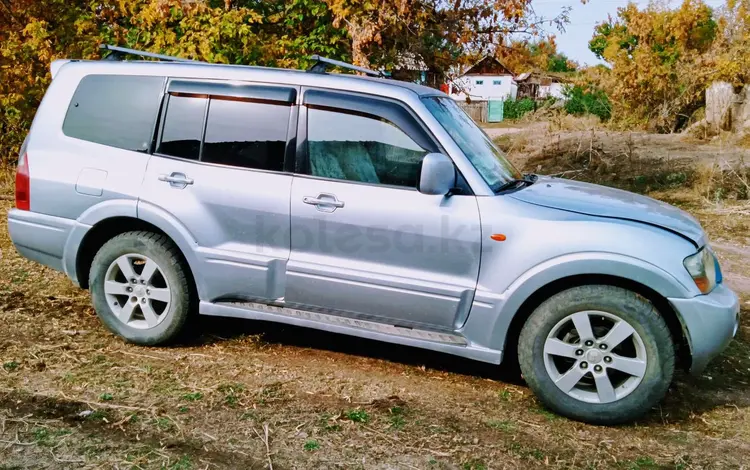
[0,126,750,470]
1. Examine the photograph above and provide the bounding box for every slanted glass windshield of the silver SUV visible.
[422,96,522,192]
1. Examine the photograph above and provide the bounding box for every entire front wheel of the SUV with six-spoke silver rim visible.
[518,285,675,425]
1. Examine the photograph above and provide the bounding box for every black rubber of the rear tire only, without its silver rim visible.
[89,231,197,346]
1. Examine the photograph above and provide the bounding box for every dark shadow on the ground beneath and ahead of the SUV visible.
[188,310,750,425]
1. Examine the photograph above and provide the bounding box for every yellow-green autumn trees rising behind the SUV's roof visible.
[0,0,566,160]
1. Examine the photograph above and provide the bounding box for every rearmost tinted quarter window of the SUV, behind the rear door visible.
[63,75,164,152]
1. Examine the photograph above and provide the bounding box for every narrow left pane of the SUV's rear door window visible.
[156,95,208,160]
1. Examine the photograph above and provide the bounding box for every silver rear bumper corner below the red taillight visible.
[8,209,75,271]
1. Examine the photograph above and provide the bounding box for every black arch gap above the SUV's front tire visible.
[503,274,690,369]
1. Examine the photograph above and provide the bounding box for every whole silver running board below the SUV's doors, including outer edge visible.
[200,301,501,364]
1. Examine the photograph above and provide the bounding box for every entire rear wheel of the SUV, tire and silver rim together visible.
[89,231,197,346]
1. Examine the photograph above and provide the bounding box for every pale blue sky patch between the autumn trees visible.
[531,0,724,65]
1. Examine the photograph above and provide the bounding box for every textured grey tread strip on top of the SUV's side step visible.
[217,302,467,346]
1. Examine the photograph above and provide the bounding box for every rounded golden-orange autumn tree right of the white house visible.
[589,0,719,131]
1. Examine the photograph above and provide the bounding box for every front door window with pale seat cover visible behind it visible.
[307,109,428,187]
